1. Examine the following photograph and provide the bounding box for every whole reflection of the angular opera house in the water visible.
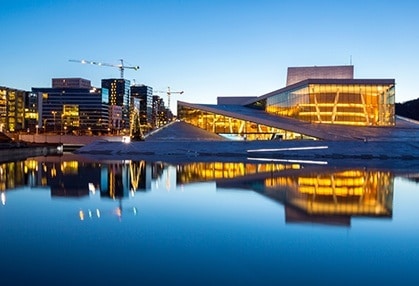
[178,163,394,225]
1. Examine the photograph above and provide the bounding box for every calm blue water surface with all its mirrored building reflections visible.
[0,155,419,285]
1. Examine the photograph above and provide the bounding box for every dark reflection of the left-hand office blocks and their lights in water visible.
[0,156,167,220]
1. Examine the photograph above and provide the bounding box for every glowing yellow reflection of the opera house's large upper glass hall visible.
[265,170,393,215]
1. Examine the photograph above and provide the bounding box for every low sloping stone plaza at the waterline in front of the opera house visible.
[75,122,419,169]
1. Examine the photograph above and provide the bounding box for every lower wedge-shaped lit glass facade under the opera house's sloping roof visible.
[178,105,315,140]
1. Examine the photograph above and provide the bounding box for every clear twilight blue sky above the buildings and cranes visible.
[0,0,419,110]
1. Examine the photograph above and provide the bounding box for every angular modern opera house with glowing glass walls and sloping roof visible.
[178,65,396,140]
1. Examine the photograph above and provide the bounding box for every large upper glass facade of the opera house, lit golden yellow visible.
[264,83,395,126]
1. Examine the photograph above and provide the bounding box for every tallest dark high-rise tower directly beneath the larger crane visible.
[102,78,130,130]
